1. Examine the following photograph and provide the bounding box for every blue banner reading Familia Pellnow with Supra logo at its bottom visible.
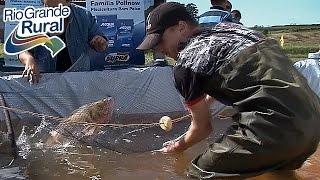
[86,0,145,69]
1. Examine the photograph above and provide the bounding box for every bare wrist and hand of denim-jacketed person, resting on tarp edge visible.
[20,53,41,83]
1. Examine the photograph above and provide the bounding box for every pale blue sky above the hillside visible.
[167,0,320,27]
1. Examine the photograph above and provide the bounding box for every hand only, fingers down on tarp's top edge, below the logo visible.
[22,57,41,83]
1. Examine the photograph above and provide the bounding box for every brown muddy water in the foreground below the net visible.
[0,117,320,180]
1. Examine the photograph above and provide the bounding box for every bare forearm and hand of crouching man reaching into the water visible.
[163,98,213,153]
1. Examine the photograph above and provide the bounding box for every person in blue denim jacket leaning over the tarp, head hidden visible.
[18,0,108,82]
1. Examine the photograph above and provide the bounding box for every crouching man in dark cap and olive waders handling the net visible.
[138,2,320,179]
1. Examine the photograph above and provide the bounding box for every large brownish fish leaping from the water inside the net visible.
[47,97,114,146]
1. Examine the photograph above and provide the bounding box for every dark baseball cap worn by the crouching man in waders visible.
[137,2,195,50]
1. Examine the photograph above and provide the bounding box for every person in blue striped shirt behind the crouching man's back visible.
[199,0,233,28]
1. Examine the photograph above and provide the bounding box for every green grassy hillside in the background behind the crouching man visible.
[0,24,320,65]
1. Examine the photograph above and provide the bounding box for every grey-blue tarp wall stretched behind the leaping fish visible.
[0,66,185,119]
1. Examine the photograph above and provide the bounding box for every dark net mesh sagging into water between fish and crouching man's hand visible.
[52,113,190,153]
